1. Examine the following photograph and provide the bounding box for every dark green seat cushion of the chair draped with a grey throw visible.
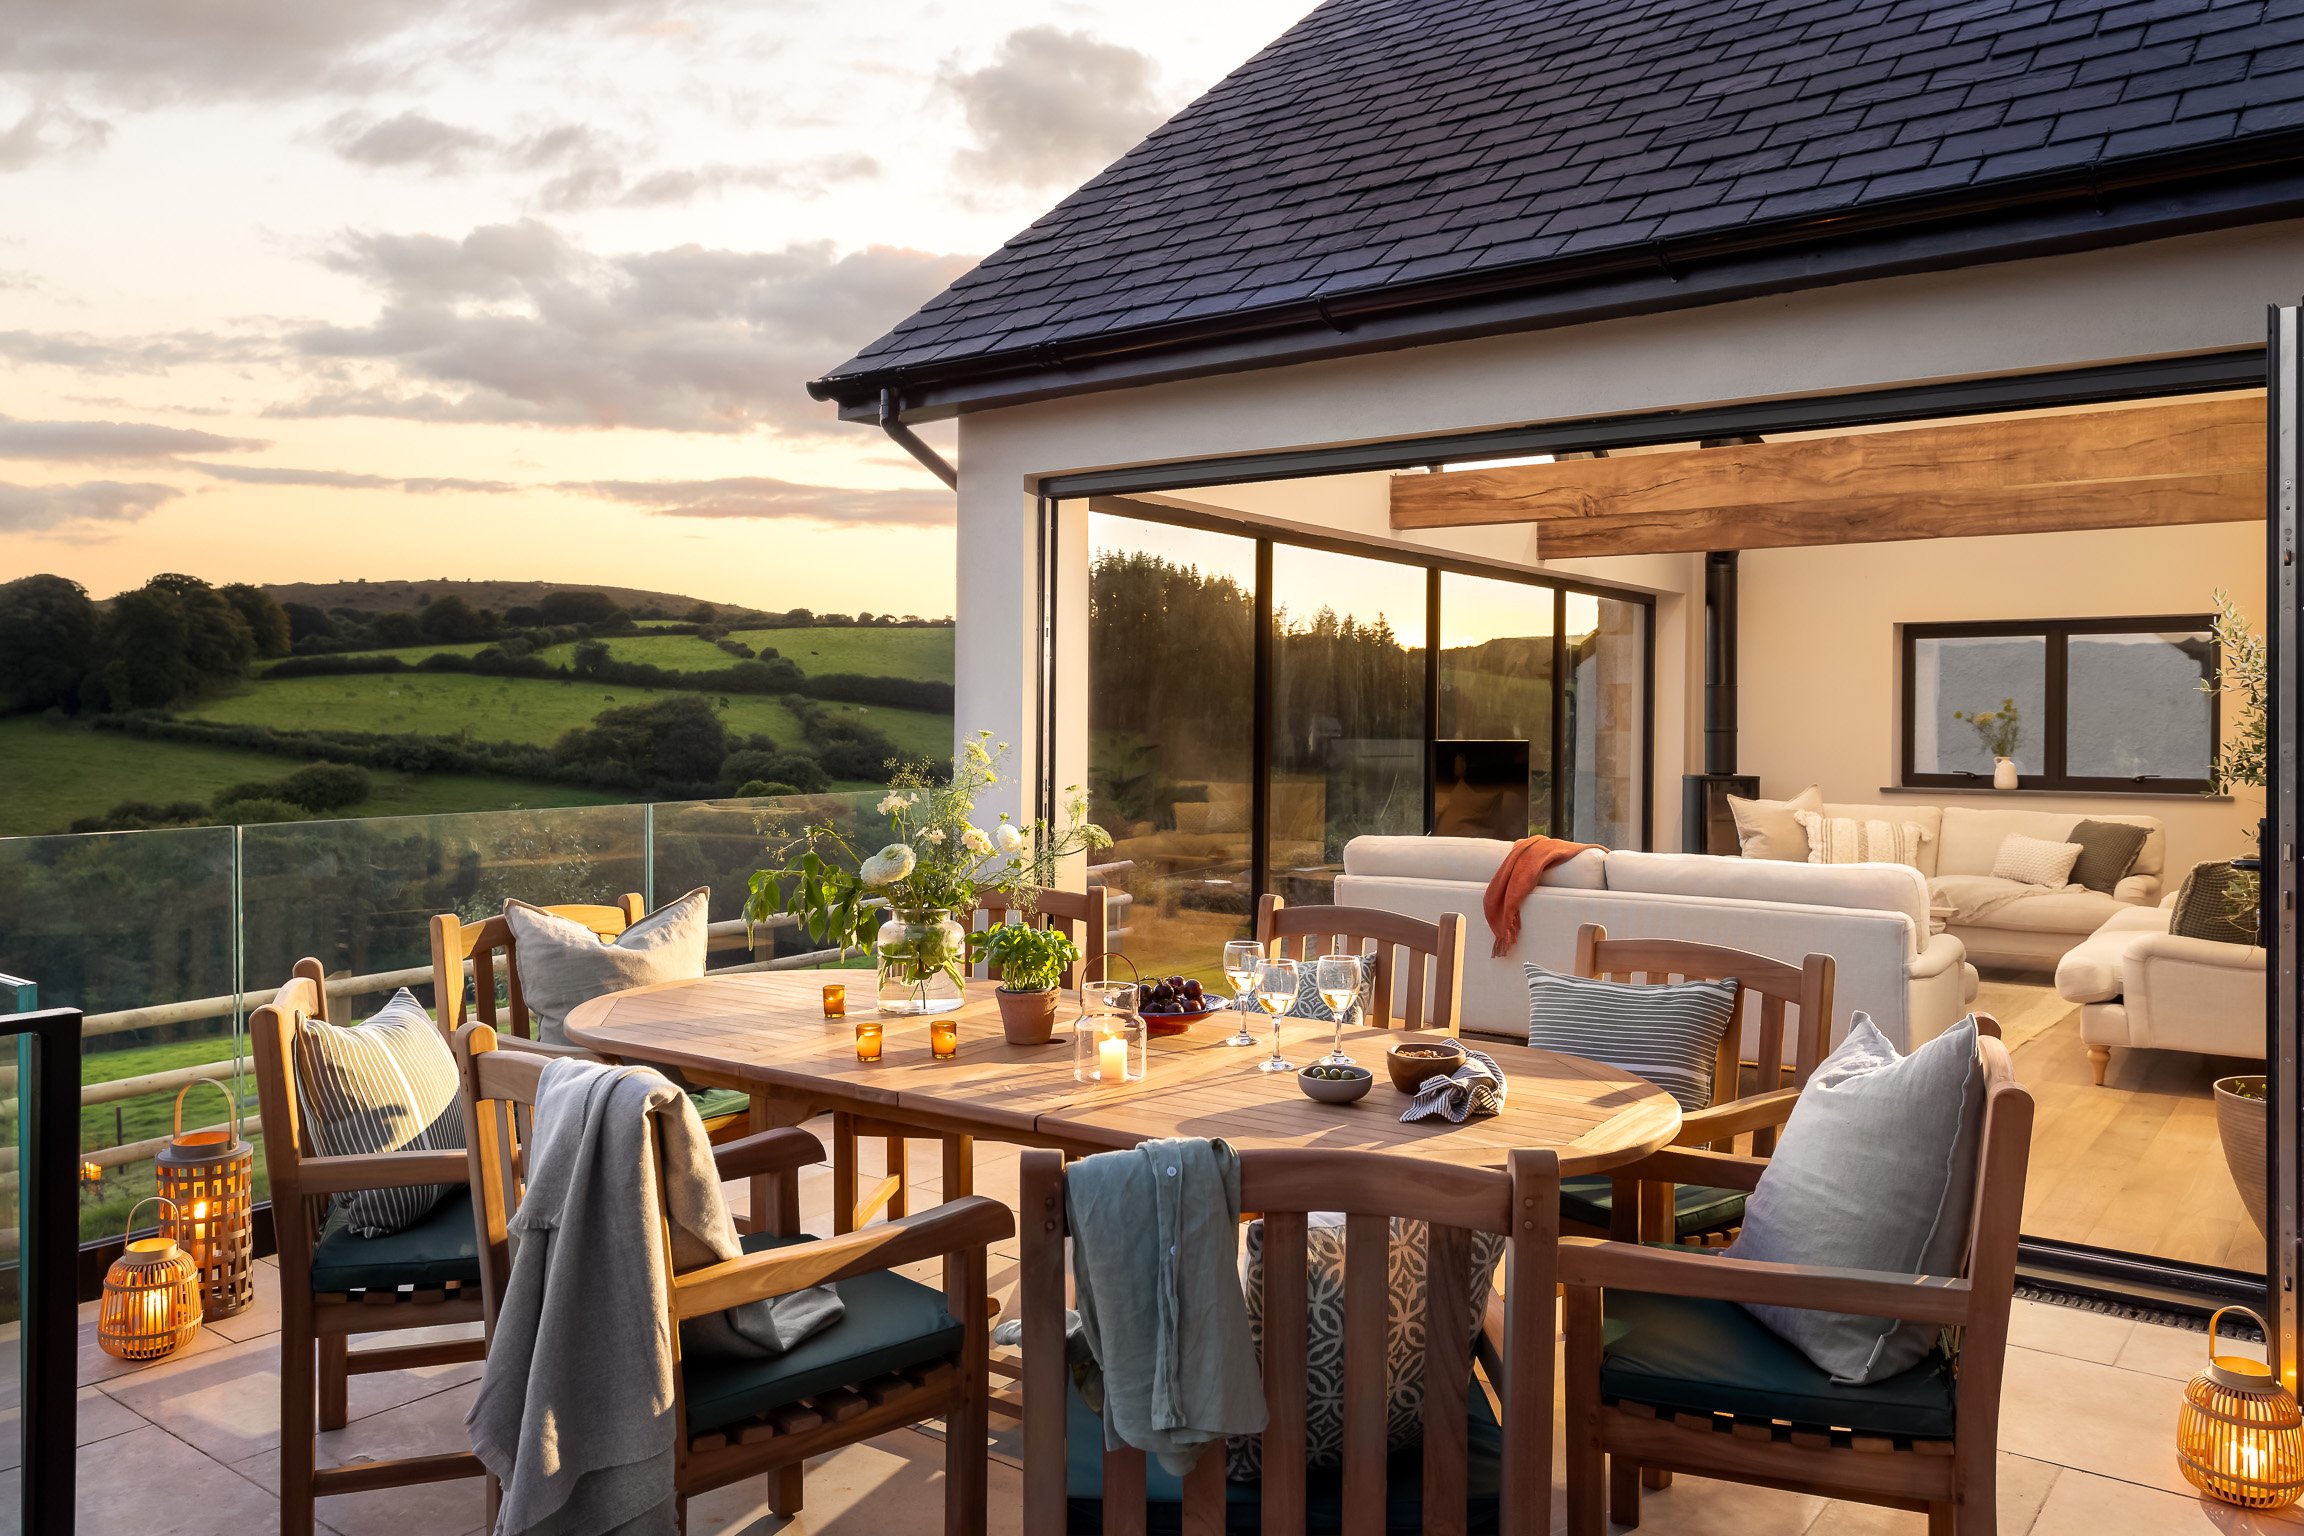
[682,1232,961,1435]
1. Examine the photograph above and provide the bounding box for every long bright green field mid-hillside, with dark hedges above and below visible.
[184,672,802,746]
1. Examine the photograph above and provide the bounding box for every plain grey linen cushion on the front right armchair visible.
[1726,1013,1984,1386]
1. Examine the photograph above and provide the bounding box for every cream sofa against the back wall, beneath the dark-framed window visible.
[1778,801,2168,969]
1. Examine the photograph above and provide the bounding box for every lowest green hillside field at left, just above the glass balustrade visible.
[0,723,629,838]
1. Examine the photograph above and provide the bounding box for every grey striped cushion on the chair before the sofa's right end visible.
[1523,965,1735,1110]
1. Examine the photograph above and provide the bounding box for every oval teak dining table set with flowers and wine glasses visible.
[567,972,1680,1232]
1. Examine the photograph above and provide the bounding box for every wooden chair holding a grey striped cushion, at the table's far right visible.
[1560,923,1834,1246]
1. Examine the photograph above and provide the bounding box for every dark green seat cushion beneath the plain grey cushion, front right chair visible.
[1599,1289,1951,1439]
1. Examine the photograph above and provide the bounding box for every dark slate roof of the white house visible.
[811,0,2304,412]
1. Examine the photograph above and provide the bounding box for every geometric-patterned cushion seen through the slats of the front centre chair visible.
[1226,1211,1505,1483]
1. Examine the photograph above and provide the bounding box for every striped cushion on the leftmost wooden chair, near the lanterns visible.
[295,988,463,1237]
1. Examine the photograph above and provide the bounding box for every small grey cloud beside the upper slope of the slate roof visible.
[942,25,1168,187]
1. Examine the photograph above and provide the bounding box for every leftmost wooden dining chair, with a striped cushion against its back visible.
[249,958,484,1536]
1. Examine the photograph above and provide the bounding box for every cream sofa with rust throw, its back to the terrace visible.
[1336,838,1977,1050]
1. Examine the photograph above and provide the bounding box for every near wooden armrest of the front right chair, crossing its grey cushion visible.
[1560,1237,1972,1324]
